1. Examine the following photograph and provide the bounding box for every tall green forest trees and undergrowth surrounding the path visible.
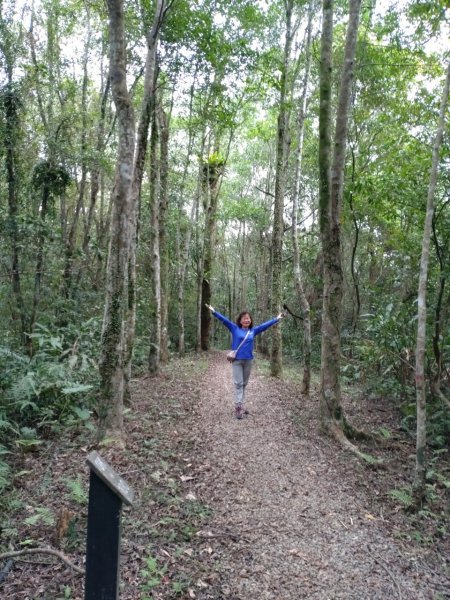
[0,0,450,598]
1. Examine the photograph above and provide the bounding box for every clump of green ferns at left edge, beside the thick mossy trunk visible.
[0,321,98,460]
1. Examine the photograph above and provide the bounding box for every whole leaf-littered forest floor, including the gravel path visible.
[0,352,450,600]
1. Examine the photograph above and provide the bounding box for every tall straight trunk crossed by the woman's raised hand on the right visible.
[270,0,294,377]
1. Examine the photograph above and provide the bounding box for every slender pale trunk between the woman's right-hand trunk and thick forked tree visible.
[292,2,313,396]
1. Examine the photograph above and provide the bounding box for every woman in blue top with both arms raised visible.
[205,304,284,419]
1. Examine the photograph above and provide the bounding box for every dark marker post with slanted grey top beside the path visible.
[84,452,134,600]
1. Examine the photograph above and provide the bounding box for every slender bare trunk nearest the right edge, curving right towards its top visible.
[413,62,450,504]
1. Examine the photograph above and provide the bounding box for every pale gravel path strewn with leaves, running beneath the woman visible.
[194,353,450,600]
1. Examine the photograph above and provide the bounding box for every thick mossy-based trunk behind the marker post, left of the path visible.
[98,0,135,443]
